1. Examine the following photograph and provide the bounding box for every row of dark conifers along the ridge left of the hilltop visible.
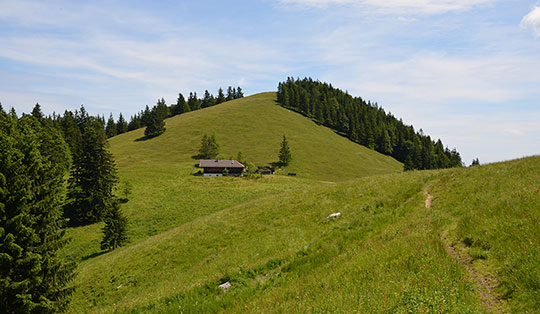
[105,86,244,137]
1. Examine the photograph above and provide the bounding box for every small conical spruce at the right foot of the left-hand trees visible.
[101,201,128,250]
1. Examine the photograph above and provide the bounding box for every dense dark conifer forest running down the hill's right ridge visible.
[278,78,462,170]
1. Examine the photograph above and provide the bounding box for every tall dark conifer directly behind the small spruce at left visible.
[65,117,118,224]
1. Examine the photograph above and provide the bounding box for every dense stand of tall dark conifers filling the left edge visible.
[0,104,127,313]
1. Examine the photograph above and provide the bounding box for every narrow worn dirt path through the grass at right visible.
[424,187,508,313]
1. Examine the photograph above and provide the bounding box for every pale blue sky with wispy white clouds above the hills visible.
[0,0,540,164]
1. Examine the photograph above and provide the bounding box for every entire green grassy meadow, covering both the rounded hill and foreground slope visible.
[62,93,540,313]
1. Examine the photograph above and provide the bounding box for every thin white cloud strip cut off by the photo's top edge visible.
[280,0,494,14]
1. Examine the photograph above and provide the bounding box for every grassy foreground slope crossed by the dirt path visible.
[66,157,540,313]
